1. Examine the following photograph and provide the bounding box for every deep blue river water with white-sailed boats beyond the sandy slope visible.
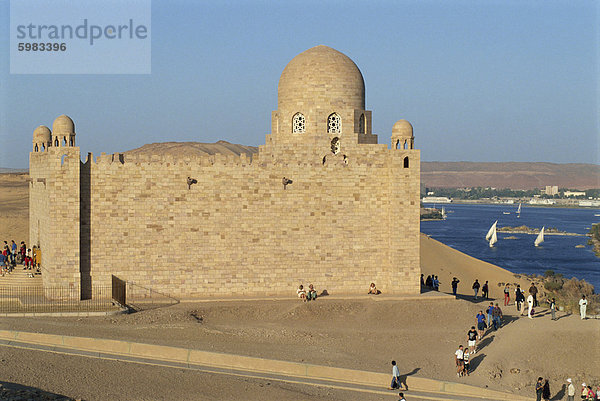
[421,204,600,292]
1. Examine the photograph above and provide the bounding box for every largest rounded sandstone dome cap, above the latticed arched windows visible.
[277,45,365,111]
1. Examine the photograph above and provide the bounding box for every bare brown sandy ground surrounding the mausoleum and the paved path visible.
[0,175,600,400]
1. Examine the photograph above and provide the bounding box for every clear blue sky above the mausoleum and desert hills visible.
[0,0,600,168]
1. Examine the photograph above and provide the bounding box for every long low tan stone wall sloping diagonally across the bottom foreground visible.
[0,330,529,401]
